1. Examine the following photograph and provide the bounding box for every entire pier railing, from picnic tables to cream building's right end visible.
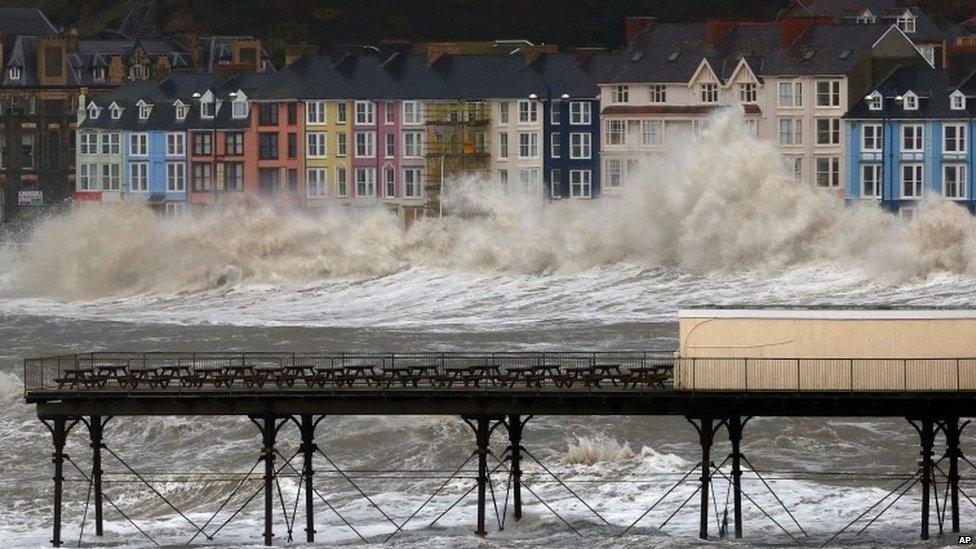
[24,351,976,396]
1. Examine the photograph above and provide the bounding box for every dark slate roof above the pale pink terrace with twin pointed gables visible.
[603,23,897,83]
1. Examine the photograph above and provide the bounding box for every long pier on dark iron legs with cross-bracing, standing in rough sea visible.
[24,351,976,546]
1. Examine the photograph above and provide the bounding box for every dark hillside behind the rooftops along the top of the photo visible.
[0,0,976,62]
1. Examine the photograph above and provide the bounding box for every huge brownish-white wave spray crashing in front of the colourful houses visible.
[5,110,976,301]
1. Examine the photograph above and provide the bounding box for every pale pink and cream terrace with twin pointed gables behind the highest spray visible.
[600,18,925,192]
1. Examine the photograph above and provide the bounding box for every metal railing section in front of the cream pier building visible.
[674,357,976,392]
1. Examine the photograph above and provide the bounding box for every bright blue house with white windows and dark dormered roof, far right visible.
[845,67,976,216]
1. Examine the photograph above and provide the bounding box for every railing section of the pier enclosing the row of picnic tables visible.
[24,351,674,398]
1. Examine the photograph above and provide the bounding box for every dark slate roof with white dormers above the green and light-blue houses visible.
[79,74,250,131]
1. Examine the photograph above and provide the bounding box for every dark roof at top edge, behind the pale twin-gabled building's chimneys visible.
[787,0,948,42]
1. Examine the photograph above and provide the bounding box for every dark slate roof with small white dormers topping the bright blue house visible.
[844,67,976,119]
